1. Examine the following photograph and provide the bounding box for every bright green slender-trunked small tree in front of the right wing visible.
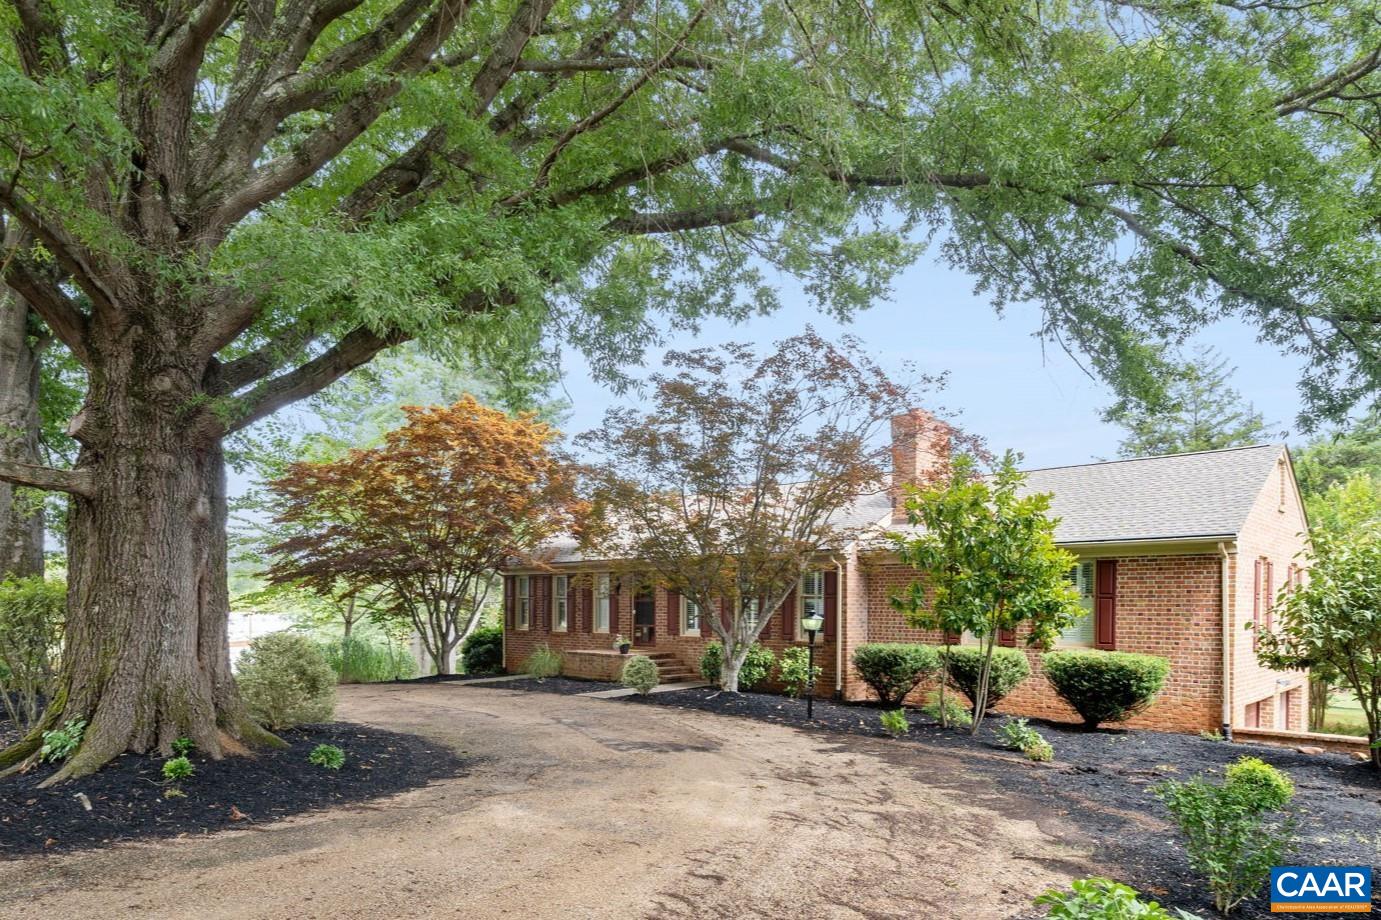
[892,452,1080,734]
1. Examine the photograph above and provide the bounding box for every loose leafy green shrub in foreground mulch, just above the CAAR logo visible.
[1155,757,1294,913]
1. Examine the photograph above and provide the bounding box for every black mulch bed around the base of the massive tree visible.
[0,722,464,859]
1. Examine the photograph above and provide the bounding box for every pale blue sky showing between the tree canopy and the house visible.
[563,257,1300,467]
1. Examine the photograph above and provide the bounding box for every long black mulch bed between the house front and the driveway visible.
[626,688,1381,917]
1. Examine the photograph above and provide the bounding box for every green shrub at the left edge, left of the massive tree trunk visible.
[0,577,68,734]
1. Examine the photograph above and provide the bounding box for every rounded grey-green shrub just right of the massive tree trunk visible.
[236,631,336,729]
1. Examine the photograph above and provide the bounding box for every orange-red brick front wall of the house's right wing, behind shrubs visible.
[845,555,1222,732]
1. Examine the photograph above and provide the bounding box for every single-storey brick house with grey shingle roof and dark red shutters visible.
[504,410,1308,731]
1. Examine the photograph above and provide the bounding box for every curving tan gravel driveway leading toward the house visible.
[0,684,1091,920]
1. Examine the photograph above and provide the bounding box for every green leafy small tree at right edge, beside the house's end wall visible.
[1248,524,1381,769]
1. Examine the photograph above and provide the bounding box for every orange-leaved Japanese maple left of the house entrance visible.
[268,396,577,674]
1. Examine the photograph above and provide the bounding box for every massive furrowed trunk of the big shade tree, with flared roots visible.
[0,330,276,783]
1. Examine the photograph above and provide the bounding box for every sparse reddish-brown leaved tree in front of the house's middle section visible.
[581,330,944,692]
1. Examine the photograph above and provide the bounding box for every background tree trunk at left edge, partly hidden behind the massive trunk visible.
[0,285,43,577]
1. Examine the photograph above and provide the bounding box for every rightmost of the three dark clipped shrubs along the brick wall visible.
[1041,649,1170,728]
